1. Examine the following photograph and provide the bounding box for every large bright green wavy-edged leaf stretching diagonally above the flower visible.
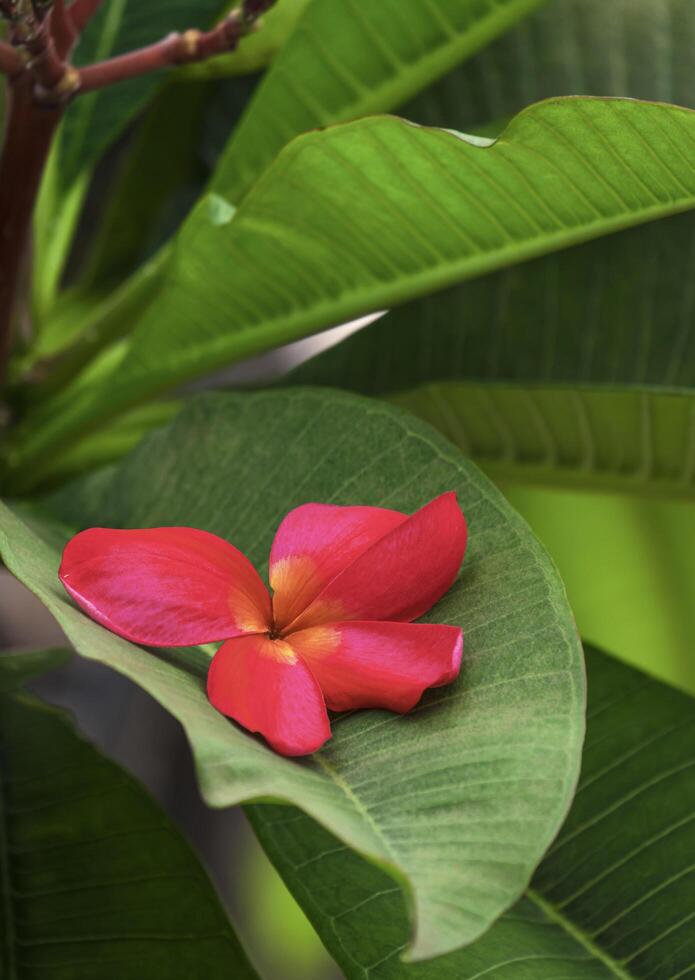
[12,99,695,481]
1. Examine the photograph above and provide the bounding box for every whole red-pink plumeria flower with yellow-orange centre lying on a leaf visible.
[60,493,466,755]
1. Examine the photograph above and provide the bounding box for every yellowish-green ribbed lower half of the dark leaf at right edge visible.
[393,382,695,497]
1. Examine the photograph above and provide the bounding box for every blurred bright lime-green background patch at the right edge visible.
[504,485,695,694]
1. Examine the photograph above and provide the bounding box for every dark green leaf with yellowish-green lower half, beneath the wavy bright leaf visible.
[293,215,695,496]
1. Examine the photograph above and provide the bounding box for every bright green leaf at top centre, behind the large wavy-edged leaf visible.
[213,0,542,203]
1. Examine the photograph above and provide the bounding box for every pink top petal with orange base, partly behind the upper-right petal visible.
[270,504,408,629]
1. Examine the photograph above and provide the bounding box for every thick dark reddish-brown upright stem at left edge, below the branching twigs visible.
[0,75,63,384]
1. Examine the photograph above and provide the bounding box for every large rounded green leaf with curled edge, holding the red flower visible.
[0,390,584,958]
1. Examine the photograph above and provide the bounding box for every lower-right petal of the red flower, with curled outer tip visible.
[287,623,463,712]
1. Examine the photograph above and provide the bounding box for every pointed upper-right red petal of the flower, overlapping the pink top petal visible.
[286,493,466,632]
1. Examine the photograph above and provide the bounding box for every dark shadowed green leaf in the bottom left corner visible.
[0,652,256,980]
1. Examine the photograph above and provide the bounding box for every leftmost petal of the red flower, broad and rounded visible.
[60,527,271,646]
